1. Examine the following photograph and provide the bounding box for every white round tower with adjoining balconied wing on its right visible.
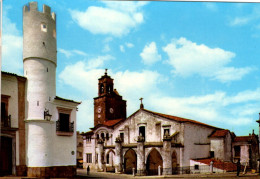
[23,2,80,177]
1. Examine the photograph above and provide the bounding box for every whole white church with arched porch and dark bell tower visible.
[83,72,259,175]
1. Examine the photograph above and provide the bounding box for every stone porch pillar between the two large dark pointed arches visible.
[137,136,146,176]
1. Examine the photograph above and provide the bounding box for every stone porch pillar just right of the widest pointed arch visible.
[163,135,172,175]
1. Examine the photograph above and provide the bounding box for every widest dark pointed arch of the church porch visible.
[146,149,163,175]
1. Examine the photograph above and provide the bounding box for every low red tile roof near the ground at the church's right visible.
[192,158,237,172]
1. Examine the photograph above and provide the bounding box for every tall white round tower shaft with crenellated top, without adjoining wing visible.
[23,2,57,176]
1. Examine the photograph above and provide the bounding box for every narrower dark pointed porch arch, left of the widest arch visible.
[124,149,137,174]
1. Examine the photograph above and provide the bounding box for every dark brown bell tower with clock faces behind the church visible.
[94,69,126,126]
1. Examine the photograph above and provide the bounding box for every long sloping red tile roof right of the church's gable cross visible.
[142,109,219,129]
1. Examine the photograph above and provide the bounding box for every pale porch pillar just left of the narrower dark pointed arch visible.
[115,137,123,173]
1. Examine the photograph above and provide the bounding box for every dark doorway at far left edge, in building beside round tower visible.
[0,136,13,176]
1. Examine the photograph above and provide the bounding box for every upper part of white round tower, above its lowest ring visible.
[23,2,57,120]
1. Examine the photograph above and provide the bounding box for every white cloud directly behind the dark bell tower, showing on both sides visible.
[59,60,164,130]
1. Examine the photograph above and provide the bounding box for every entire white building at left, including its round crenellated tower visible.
[0,2,80,177]
